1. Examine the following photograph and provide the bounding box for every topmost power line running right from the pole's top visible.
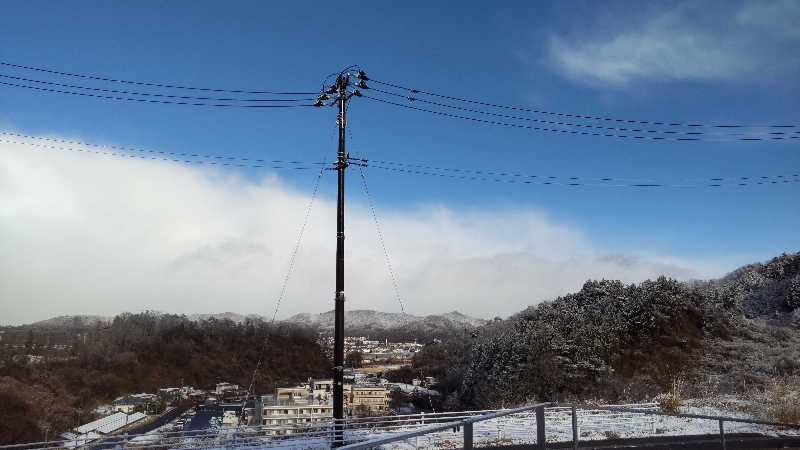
[370,78,800,128]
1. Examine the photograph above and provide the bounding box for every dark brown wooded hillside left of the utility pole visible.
[0,313,330,443]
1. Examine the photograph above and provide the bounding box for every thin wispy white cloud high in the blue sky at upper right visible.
[548,0,800,85]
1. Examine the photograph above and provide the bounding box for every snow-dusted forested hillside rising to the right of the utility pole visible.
[414,253,800,409]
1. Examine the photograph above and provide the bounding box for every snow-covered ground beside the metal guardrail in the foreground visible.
[75,399,800,450]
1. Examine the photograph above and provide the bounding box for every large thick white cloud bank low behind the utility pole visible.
[0,134,722,323]
